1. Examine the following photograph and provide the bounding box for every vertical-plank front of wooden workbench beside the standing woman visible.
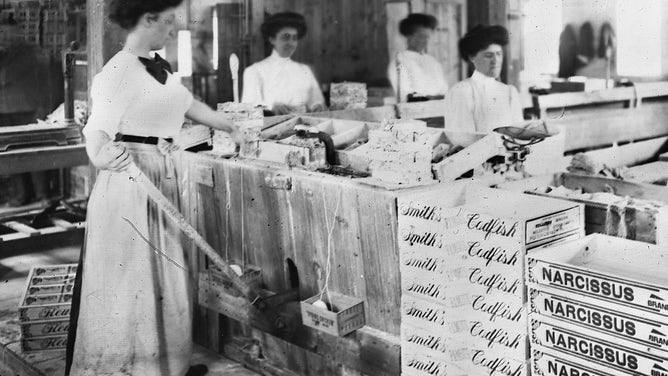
[177,152,428,375]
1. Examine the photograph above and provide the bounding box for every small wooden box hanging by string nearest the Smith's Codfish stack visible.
[301,292,366,337]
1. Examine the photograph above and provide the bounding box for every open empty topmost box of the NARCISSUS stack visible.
[527,234,668,317]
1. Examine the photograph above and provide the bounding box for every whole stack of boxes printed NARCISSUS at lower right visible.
[526,234,668,376]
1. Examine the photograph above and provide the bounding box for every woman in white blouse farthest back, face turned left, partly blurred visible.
[387,13,448,102]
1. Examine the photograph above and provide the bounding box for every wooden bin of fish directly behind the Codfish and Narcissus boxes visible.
[499,173,668,245]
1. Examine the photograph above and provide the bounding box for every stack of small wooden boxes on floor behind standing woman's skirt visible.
[19,264,77,352]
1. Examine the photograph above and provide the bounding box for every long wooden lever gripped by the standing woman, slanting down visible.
[126,163,258,302]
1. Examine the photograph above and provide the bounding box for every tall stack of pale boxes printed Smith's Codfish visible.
[398,183,584,376]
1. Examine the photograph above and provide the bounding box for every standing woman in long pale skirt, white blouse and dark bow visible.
[67,0,240,376]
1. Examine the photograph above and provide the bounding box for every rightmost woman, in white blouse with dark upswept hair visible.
[445,25,523,133]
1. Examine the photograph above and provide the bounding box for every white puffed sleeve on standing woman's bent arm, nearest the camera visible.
[83,66,136,140]
